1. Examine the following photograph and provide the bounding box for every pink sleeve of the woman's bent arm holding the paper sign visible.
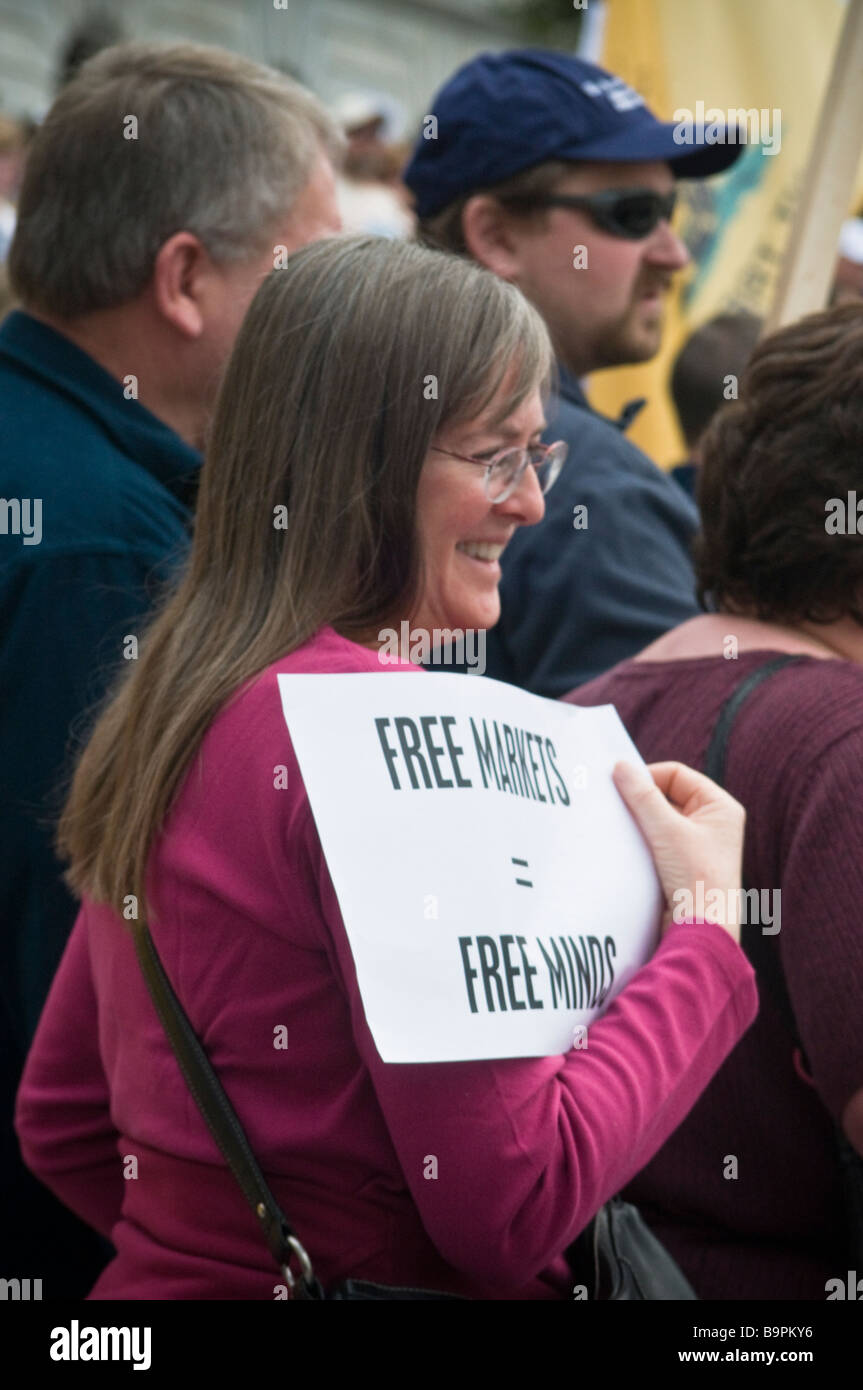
[327,876,757,1284]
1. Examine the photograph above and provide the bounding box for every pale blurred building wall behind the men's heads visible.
[0,0,523,135]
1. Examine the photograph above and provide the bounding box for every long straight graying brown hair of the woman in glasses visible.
[60,238,550,915]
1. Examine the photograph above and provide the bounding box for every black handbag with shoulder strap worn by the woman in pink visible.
[129,922,698,1302]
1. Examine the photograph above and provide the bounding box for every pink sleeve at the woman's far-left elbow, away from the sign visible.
[15,910,124,1238]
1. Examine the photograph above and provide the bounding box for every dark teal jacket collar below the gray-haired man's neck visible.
[0,309,202,503]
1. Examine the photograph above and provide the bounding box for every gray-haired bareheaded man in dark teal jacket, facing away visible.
[0,43,342,1298]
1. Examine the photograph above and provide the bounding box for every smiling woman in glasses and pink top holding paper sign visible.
[18,239,756,1300]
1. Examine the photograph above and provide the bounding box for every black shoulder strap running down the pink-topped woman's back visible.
[131,922,321,1298]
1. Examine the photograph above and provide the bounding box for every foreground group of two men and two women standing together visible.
[0,43,863,1300]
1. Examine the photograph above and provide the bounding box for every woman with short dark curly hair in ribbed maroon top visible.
[567,303,863,1300]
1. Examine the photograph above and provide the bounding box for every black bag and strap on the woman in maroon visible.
[705,655,863,1269]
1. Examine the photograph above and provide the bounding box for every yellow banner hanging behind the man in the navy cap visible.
[589,0,863,467]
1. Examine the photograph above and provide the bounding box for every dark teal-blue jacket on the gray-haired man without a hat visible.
[0,311,200,1297]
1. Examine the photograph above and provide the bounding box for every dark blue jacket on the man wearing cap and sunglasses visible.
[486,368,700,696]
